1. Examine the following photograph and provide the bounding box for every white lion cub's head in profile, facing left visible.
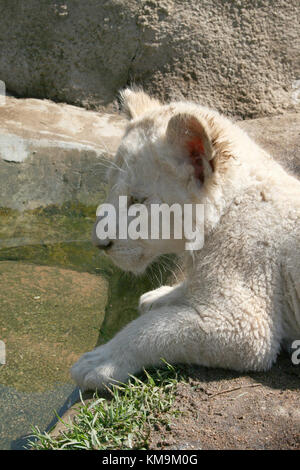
[93,89,245,273]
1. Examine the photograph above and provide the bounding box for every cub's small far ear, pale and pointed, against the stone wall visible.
[120,88,161,119]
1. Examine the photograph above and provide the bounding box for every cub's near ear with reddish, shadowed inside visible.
[166,113,214,183]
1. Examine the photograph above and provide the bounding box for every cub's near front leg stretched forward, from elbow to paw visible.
[71,303,279,390]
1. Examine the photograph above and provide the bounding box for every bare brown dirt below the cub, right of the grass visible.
[150,355,300,450]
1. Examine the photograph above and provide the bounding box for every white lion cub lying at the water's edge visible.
[72,89,300,390]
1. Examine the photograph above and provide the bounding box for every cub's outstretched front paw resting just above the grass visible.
[71,345,127,391]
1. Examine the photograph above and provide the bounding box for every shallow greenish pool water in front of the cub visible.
[0,203,175,449]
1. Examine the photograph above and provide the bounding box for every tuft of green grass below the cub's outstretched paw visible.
[30,364,183,450]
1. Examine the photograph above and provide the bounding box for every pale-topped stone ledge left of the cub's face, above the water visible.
[0,98,125,210]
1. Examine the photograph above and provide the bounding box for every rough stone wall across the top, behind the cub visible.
[0,0,300,117]
